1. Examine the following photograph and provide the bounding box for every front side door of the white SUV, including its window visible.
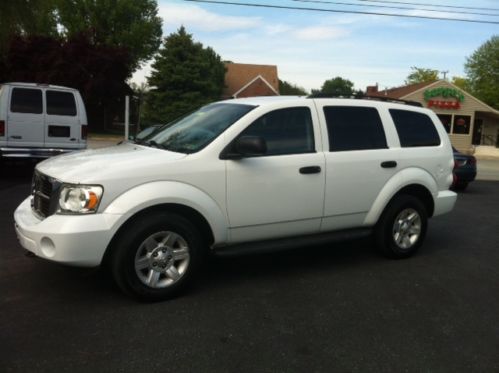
[225,104,325,243]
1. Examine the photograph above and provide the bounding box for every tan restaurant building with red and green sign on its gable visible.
[366,80,499,152]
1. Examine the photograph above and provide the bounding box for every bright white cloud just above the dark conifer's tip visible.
[159,4,261,31]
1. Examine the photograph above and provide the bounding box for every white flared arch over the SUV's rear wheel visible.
[364,167,438,226]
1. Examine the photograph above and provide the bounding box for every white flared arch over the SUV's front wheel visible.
[103,181,228,243]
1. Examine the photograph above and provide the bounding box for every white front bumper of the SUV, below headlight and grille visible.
[14,197,122,267]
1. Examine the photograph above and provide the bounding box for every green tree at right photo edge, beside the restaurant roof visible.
[464,35,499,109]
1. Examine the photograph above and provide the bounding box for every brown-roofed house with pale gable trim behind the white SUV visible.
[223,62,279,98]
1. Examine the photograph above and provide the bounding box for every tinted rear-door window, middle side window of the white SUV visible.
[324,106,387,152]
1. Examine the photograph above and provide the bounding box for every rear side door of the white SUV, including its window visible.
[317,103,400,231]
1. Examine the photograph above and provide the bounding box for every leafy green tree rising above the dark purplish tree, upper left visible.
[53,0,162,72]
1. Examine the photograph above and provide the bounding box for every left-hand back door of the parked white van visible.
[7,87,45,147]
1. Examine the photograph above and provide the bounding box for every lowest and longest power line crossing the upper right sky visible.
[184,0,499,25]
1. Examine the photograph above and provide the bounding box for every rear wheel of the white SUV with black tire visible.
[374,194,428,259]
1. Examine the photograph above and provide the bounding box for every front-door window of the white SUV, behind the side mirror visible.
[240,107,315,155]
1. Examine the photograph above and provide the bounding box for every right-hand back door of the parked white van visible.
[45,89,80,148]
